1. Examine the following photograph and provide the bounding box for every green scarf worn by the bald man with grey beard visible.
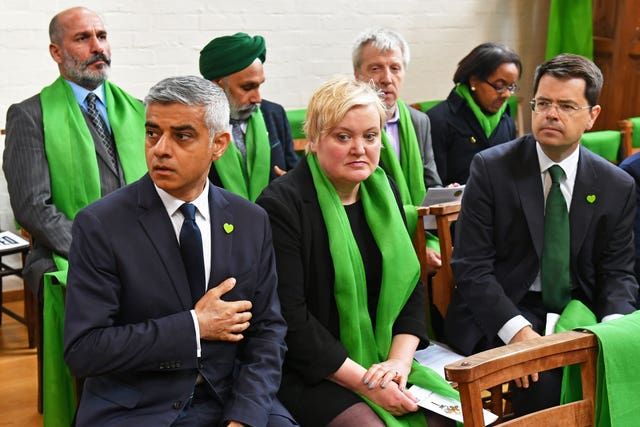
[40,77,147,425]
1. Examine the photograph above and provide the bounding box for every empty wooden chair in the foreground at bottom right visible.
[445,331,598,427]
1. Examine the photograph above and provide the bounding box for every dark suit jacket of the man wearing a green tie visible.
[445,135,638,354]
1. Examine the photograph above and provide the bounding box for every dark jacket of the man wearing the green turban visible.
[209,99,298,187]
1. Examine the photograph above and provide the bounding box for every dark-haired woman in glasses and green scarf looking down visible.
[427,43,522,185]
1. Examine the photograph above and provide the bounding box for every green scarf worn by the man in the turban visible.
[214,109,271,202]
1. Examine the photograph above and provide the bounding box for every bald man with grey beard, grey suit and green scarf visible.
[3,7,145,292]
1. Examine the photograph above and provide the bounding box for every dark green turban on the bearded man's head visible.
[200,33,267,80]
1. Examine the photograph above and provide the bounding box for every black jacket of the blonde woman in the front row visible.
[256,159,426,402]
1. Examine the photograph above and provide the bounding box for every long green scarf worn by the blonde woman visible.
[307,154,458,426]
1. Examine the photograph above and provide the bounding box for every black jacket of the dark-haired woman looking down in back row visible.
[427,90,516,185]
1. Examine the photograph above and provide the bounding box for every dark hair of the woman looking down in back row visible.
[453,42,522,85]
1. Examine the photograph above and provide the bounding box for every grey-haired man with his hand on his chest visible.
[65,76,292,426]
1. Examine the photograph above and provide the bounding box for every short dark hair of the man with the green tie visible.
[533,53,604,106]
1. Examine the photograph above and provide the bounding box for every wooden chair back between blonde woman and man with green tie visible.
[414,202,461,318]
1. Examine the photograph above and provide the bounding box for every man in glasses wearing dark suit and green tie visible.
[445,54,638,415]
